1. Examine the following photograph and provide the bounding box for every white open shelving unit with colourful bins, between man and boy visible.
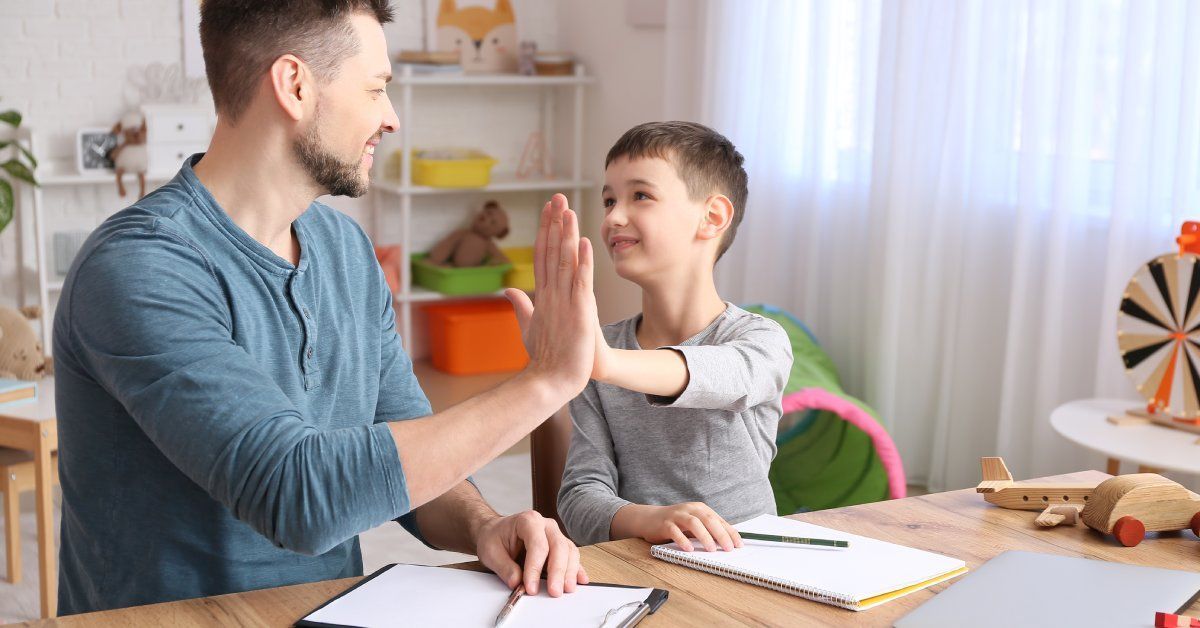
[371,65,594,354]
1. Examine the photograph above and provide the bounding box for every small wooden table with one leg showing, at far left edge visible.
[0,377,59,617]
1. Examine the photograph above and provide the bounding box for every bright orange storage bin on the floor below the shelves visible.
[425,300,529,375]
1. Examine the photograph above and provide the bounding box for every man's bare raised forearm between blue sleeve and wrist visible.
[388,371,571,509]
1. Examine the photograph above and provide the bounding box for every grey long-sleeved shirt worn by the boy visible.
[558,304,792,545]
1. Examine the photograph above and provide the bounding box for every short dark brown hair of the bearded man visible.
[200,0,392,121]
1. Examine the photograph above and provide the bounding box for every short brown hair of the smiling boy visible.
[604,121,749,259]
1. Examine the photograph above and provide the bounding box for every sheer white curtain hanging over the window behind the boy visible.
[667,0,1200,490]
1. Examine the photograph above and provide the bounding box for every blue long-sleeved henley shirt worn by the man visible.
[54,155,430,614]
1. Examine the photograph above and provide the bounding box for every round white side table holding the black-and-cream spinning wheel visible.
[1050,399,1200,476]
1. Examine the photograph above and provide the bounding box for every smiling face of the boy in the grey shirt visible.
[600,157,715,283]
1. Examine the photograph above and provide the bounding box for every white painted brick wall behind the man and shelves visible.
[0,0,560,314]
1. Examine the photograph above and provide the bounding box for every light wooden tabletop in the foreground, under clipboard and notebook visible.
[28,471,1200,628]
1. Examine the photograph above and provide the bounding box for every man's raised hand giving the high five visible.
[504,195,598,396]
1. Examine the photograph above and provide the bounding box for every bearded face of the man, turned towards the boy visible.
[294,13,400,197]
